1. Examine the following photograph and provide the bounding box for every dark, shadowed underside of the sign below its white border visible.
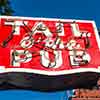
[0,72,100,91]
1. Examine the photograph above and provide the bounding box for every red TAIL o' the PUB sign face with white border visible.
[0,16,100,76]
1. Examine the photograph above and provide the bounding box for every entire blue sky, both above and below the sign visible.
[0,0,100,100]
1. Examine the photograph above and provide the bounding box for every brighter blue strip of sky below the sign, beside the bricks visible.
[0,90,66,100]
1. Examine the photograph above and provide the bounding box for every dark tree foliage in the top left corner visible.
[0,0,14,16]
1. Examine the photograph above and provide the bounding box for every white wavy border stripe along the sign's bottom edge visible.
[0,66,100,76]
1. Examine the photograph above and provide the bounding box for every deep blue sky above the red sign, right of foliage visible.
[10,0,100,27]
